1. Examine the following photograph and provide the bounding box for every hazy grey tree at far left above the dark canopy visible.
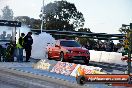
[2,6,13,20]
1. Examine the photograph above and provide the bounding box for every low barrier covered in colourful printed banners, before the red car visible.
[33,60,105,76]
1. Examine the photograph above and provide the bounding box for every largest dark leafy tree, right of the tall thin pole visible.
[40,0,85,31]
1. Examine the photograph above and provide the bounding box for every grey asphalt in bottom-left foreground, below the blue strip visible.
[0,68,87,88]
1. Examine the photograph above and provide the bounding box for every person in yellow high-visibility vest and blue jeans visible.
[16,33,25,62]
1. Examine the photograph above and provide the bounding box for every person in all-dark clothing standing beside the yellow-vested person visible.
[24,32,33,62]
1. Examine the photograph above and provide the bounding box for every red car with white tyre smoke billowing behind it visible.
[47,39,90,64]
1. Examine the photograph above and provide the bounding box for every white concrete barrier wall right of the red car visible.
[90,50,127,65]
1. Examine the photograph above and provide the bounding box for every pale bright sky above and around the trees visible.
[0,0,132,34]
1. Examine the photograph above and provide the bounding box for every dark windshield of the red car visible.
[60,41,81,47]
